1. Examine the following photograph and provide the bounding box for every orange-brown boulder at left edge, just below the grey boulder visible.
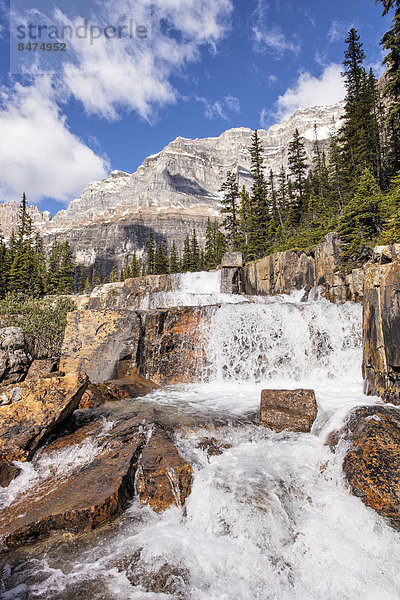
[0,373,88,461]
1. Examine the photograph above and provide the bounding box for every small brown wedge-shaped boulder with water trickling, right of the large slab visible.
[138,427,193,512]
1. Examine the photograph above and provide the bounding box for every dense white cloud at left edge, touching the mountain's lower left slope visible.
[0,76,109,201]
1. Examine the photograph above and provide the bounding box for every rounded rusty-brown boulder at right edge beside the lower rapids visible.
[334,406,400,522]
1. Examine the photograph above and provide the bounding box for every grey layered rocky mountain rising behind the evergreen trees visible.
[0,104,343,275]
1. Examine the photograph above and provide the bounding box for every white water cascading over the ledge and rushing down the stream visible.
[1,274,400,600]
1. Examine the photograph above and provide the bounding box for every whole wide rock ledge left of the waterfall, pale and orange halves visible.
[60,306,216,384]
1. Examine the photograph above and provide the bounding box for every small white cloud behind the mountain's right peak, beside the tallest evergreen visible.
[272,63,346,121]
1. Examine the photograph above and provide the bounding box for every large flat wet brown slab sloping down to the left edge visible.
[0,418,145,547]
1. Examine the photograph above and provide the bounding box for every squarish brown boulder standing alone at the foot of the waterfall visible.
[260,389,318,433]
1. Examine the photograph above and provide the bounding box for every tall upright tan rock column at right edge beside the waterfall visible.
[363,261,400,404]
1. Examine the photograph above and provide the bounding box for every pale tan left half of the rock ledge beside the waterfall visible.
[60,310,141,383]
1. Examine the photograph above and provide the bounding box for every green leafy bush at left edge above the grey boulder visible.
[0,294,76,358]
